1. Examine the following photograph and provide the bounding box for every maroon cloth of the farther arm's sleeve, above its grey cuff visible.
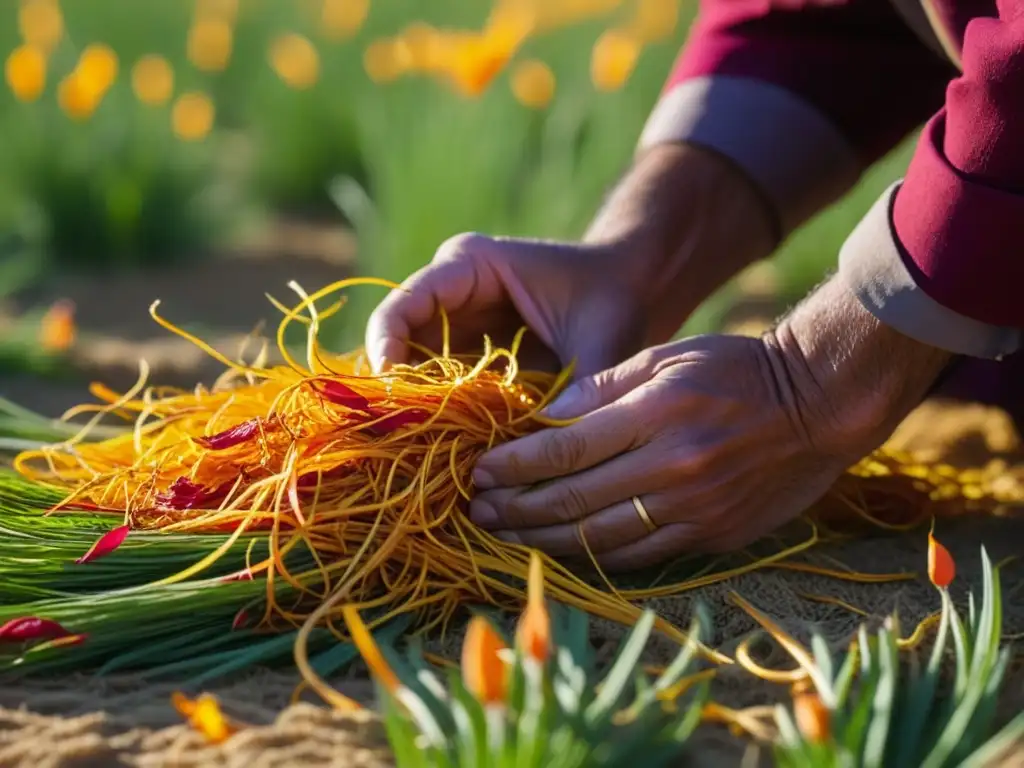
[667,0,954,165]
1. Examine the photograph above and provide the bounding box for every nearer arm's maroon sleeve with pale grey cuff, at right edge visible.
[840,6,1024,358]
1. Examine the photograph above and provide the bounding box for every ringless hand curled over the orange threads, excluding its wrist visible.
[366,233,646,377]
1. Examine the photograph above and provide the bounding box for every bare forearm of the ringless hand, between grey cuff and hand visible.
[585,143,777,343]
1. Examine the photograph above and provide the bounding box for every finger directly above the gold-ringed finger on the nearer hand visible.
[469,445,678,530]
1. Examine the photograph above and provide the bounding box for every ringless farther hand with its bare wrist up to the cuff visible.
[366,144,774,376]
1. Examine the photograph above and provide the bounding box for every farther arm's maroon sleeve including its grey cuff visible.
[640,0,951,237]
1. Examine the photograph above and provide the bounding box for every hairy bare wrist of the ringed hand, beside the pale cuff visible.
[764,279,952,460]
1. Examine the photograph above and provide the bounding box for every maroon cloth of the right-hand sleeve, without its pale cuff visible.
[892,6,1024,329]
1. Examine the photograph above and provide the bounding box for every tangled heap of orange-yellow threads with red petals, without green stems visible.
[14,279,774,671]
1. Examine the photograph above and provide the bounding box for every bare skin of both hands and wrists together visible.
[367,151,949,570]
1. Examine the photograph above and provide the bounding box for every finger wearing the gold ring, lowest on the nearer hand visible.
[495,501,647,557]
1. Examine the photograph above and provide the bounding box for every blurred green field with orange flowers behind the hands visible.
[0,0,907,409]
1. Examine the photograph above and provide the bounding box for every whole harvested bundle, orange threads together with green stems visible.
[0,279,1019,698]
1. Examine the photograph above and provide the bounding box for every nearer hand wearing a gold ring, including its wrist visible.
[470,282,948,570]
